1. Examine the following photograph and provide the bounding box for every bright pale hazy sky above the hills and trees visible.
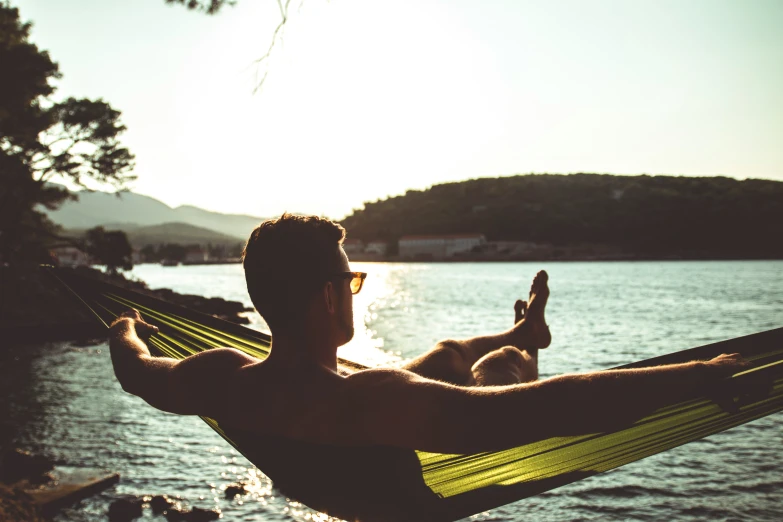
[11,0,783,219]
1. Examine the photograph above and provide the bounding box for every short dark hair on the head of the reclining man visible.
[242,213,345,331]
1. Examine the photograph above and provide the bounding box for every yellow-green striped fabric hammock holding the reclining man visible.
[51,269,783,520]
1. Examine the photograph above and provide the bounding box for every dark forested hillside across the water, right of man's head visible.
[342,174,783,258]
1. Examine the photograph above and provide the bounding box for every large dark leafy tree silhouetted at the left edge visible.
[0,2,135,263]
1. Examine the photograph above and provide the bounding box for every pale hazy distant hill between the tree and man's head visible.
[46,184,263,240]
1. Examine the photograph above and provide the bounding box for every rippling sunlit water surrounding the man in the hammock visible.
[0,261,783,521]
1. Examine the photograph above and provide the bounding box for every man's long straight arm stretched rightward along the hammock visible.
[335,355,745,453]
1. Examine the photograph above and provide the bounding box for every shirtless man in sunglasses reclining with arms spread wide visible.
[110,215,744,520]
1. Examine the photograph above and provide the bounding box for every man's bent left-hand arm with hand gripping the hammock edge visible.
[109,310,258,416]
